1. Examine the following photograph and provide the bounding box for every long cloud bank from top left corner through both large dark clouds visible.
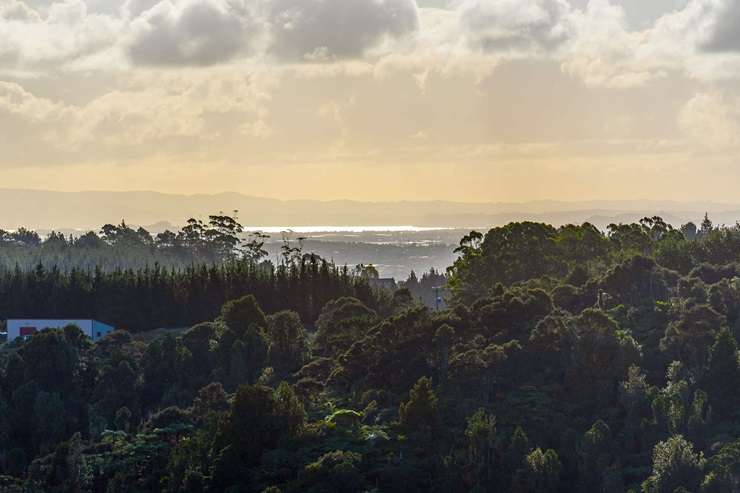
[0,0,420,74]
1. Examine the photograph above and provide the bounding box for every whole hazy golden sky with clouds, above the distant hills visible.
[0,0,740,202]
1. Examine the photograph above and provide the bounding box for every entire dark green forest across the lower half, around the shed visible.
[0,216,740,493]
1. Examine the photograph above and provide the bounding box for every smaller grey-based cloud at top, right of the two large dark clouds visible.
[458,0,571,52]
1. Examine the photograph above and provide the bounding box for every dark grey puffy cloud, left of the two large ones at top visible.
[127,0,258,66]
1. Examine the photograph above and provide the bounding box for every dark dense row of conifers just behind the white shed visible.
[0,243,379,332]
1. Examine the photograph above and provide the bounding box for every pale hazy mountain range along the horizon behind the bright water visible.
[0,189,740,231]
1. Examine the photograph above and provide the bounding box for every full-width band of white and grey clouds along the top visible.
[0,0,740,90]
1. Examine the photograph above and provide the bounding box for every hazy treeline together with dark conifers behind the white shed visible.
[0,215,384,332]
